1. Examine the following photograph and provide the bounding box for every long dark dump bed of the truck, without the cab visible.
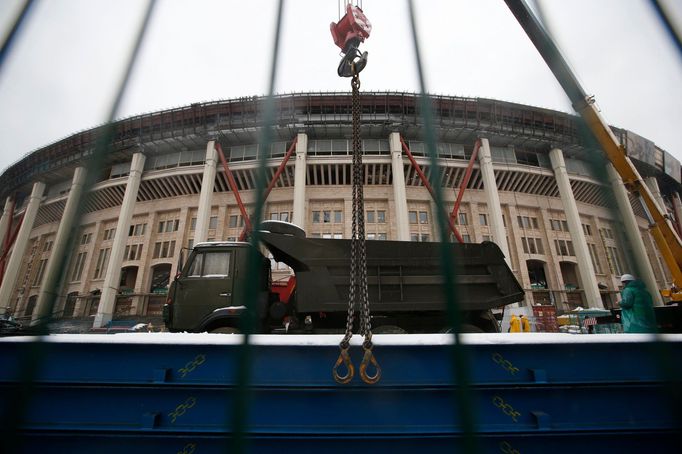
[261,231,523,313]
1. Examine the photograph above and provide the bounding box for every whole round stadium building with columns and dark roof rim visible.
[0,93,682,326]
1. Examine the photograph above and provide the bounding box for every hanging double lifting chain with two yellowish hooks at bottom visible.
[333,64,381,384]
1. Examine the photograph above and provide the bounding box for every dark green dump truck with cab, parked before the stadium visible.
[164,221,523,333]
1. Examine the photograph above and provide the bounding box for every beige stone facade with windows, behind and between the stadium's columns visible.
[2,92,669,318]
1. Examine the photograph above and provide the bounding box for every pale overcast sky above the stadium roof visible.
[0,0,682,176]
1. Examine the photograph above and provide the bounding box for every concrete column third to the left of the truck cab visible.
[0,181,45,307]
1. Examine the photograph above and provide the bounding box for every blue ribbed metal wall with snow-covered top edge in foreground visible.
[0,333,682,453]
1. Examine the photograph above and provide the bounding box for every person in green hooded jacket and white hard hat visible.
[619,274,656,333]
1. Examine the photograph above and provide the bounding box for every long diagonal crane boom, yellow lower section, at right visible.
[504,0,682,301]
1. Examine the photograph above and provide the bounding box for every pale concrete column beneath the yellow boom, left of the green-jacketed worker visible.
[606,164,663,306]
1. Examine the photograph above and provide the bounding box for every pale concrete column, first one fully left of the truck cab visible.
[93,153,145,328]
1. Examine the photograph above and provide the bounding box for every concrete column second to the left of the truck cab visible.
[31,167,87,324]
